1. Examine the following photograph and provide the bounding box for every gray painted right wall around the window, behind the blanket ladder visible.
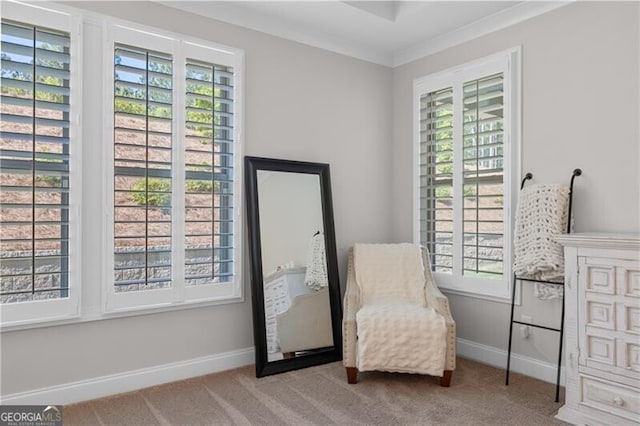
[392,2,640,363]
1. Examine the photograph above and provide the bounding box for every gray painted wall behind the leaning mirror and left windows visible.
[0,2,392,395]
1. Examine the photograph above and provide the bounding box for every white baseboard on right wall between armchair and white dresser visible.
[456,338,564,385]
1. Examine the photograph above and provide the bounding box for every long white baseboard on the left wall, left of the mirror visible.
[0,348,254,405]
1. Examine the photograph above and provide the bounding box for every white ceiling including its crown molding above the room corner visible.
[158,0,569,66]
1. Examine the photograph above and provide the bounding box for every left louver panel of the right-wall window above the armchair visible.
[420,88,453,273]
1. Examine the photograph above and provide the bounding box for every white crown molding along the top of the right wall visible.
[391,0,575,68]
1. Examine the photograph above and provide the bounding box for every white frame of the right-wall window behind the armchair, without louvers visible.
[413,46,521,301]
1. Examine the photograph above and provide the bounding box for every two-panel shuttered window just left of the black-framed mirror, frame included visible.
[105,25,242,311]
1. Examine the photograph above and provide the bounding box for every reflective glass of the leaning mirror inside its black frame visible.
[256,170,334,362]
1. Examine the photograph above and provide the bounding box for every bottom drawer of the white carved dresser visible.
[581,376,640,421]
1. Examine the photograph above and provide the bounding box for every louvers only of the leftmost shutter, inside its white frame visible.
[0,20,71,304]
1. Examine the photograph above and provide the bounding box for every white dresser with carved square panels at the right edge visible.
[556,233,640,425]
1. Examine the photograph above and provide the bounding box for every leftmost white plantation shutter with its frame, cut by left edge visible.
[0,3,81,326]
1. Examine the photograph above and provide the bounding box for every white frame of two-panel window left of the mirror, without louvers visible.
[102,20,244,314]
